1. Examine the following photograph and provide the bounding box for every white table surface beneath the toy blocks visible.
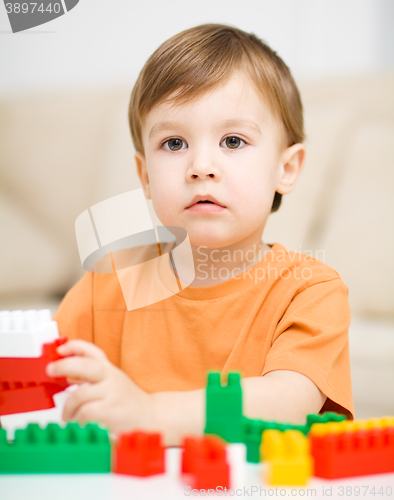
[0,445,394,500]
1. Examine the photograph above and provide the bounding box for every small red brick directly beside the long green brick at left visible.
[112,431,165,476]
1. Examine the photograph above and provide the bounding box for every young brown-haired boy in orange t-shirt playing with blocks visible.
[47,24,353,444]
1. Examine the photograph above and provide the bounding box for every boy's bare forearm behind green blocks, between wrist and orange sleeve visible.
[152,370,326,445]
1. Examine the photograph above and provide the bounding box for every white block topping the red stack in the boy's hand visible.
[0,309,59,358]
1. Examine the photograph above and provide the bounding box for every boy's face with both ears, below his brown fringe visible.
[136,69,304,248]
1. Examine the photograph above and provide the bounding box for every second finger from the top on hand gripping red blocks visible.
[46,356,105,382]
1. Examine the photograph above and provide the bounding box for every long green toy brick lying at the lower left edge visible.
[0,423,110,474]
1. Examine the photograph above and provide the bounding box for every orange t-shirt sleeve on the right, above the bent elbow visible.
[262,278,354,418]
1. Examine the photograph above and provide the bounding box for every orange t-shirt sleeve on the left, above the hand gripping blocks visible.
[53,272,94,342]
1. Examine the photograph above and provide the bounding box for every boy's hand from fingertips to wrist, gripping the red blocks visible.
[46,340,154,433]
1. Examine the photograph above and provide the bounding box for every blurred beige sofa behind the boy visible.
[0,74,394,417]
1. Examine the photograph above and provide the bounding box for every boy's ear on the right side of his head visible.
[276,144,305,194]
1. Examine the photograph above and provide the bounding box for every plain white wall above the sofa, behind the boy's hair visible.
[0,0,394,95]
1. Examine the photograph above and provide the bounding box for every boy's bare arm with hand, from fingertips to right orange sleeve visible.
[46,340,325,445]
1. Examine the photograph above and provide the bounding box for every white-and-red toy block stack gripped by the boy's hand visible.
[0,309,69,415]
